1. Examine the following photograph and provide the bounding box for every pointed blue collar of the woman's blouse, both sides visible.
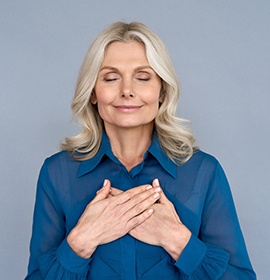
[77,132,177,178]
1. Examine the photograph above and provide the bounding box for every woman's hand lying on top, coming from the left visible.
[67,180,161,258]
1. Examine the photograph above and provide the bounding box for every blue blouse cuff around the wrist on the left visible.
[56,239,92,273]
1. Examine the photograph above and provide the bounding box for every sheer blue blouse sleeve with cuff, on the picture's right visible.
[174,159,256,280]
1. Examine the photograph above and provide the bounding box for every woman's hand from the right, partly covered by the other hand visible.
[129,179,191,260]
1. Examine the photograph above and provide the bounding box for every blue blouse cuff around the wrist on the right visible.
[174,235,207,275]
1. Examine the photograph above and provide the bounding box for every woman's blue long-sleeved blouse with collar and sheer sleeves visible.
[25,134,256,280]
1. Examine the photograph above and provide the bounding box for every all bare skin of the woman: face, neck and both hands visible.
[67,41,191,260]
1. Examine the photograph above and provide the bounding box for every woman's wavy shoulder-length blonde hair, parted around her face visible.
[61,22,195,163]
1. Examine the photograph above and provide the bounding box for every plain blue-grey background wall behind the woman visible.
[0,0,270,280]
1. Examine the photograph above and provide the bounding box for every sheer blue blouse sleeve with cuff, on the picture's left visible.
[25,161,91,280]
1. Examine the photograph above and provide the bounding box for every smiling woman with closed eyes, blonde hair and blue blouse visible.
[26,22,256,280]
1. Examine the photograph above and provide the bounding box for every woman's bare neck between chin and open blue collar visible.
[105,125,153,171]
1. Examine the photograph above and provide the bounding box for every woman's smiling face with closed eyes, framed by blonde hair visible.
[91,41,162,133]
